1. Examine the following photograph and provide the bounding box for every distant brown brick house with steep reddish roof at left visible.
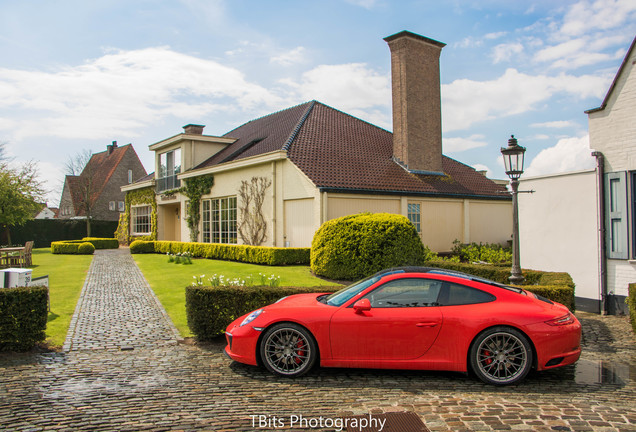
[58,141,146,221]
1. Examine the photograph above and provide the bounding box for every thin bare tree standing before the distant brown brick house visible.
[66,150,96,237]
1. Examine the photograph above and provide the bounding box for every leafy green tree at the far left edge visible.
[0,143,46,244]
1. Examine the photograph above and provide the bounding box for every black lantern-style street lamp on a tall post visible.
[501,135,526,284]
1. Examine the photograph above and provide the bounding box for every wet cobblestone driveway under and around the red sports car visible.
[0,248,636,432]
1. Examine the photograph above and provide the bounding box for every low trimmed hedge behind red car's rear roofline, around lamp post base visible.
[425,261,575,311]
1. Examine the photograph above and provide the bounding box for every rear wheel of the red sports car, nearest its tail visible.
[470,326,533,385]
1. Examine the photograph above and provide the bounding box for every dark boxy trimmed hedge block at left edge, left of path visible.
[0,286,48,351]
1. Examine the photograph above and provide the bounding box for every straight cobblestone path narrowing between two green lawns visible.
[64,248,177,351]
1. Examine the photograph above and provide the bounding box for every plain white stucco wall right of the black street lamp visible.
[519,170,600,300]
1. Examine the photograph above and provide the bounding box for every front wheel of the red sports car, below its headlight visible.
[259,323,318,377]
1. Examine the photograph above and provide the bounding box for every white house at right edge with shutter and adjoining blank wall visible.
[519,33,636,314]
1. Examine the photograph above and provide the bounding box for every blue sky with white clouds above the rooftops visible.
[0,0,636,206]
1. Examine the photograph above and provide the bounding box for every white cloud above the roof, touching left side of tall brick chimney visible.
[281,63,391,114]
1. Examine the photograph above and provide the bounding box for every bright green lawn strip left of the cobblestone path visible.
[31,248,93,346]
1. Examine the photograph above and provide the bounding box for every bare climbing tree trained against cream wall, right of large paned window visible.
[238,177,272,246]
